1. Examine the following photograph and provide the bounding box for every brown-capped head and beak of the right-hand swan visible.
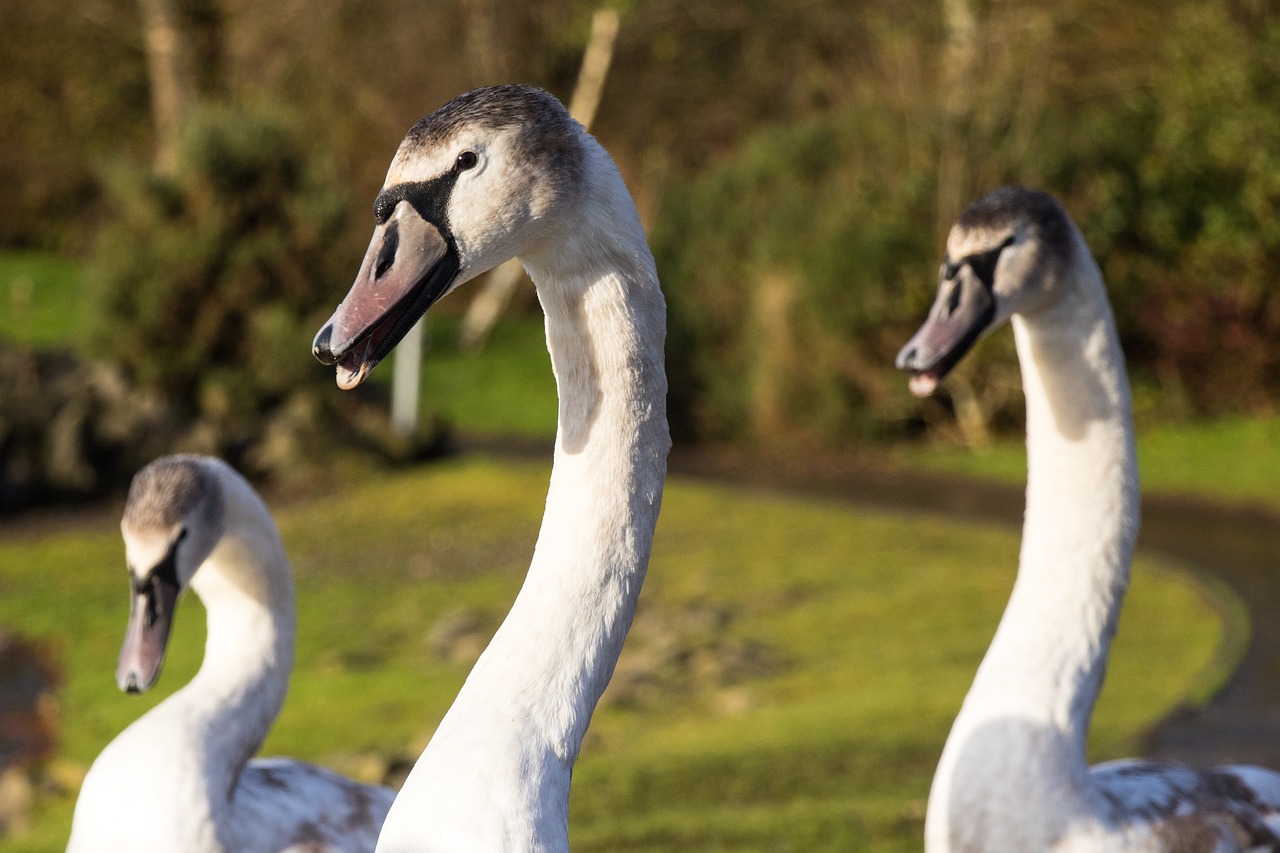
[896,187,1075,397]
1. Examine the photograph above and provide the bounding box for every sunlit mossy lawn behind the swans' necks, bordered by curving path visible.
[0,459,1222,852]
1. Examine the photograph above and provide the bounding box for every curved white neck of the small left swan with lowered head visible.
[162,478,297,797]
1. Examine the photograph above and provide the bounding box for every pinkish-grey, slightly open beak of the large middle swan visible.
[311,201,458,389]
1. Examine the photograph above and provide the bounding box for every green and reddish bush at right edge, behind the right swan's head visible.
[1098,5,1280,412]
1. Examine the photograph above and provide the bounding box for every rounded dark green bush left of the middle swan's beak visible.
[87,102,358,411]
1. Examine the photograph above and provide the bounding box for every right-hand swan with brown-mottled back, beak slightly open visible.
[897,187,1280,853]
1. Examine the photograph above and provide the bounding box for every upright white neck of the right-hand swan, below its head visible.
[996,277,1138,722]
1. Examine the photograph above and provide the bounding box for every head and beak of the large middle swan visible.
[311,86,585,388]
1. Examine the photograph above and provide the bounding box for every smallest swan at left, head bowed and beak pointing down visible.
[67,456,394,853]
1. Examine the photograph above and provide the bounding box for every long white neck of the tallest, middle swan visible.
[378,141,671,853]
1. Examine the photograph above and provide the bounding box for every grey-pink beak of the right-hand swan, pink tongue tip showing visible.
[895,268,996,397]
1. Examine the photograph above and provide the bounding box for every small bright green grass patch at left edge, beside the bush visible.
[0,252,87,346]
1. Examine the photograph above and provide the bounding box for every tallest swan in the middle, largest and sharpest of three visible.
[314,86,671,853]
